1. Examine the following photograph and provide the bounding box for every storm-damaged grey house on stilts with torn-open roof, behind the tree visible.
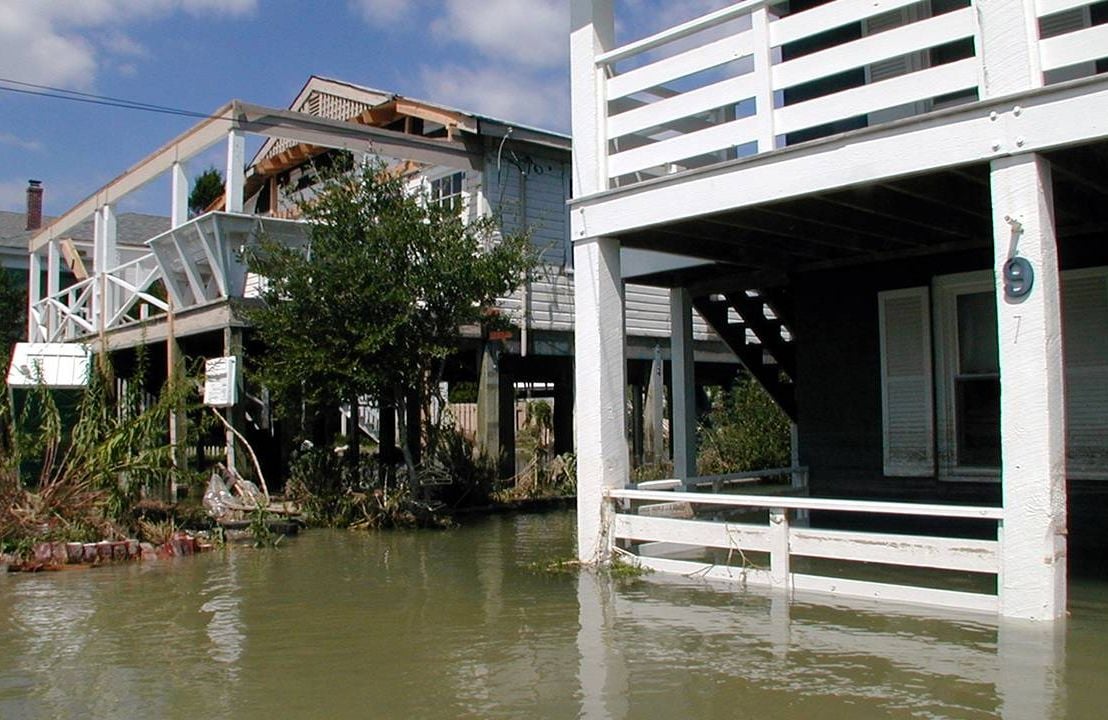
[19,76,736,487]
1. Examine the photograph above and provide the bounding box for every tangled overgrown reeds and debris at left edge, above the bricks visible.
[0,357,186,551]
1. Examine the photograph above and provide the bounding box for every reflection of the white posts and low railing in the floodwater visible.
[577,562,1067,720]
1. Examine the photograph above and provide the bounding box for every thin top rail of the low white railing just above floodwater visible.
[605,488,1004,521]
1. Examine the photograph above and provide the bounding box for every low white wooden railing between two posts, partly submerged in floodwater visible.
[607,488,1004,611]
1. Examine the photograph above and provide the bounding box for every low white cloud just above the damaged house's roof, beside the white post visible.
[421,66,570,131]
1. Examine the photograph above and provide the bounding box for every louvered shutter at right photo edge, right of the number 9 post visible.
[1061,268,1108,479]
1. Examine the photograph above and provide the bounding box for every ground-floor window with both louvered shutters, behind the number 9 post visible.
[878,267,1108,481]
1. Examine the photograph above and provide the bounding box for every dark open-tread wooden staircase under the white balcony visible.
[693,289,797,421]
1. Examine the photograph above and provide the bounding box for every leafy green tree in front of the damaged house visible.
[246,161,533,479]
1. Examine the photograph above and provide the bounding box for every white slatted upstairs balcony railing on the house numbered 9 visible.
[595,0,1108,186]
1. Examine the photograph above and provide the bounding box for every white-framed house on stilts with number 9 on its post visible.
[570,0,1108,620]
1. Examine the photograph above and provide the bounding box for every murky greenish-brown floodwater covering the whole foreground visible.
[0,513,1108,720]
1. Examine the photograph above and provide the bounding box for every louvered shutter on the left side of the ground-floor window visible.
[878,287,935,476]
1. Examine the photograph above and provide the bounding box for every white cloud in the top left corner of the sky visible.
[0,0,257,89]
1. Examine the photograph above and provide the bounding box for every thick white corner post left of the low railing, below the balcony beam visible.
[574,238,630,563]
